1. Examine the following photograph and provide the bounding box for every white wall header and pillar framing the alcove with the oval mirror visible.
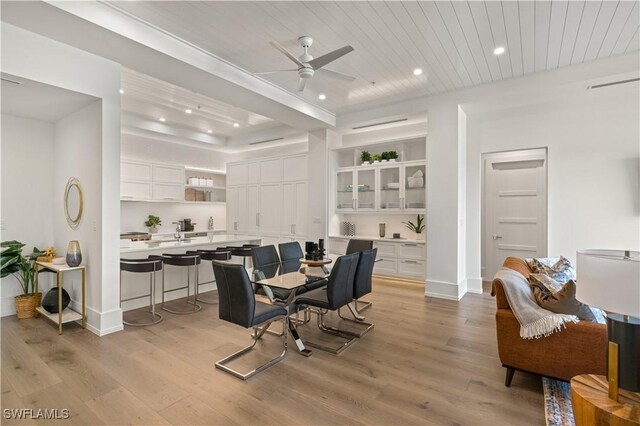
[1,22,122,335]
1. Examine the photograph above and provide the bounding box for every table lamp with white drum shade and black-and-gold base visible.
[576,250,640,401]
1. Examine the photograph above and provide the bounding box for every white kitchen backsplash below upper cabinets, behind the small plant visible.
[120,202,227,233]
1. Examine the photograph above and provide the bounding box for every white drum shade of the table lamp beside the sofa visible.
[576,250,640,317]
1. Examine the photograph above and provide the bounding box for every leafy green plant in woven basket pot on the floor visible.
[0,240,43,319]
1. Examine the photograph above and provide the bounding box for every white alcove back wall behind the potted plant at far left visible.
[0,114,55,316]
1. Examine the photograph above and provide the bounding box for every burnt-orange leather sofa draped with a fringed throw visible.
[493,257,607,386]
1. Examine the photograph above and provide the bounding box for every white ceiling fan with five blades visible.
[256,36,355,92]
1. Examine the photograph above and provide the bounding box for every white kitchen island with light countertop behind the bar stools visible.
[120,234,262,311]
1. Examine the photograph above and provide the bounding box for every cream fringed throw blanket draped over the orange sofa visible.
[494,268,580,339]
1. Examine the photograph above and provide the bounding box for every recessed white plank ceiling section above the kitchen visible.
[121,68,279,139]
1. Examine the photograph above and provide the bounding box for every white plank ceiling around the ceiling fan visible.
[110,0,640,113]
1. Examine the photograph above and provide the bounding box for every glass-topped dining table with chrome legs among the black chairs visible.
[251,263,328,356]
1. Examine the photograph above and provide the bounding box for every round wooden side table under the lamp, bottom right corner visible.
[571,374,640,426]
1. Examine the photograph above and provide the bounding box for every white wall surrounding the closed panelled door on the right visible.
[468,79,640,279]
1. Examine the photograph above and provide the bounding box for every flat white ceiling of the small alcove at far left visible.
[0,73,97,123]
